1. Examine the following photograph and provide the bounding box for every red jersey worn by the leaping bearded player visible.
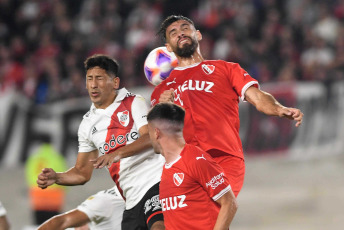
[151,60,259,158]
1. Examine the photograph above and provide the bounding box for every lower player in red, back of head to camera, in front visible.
[147,103,237,229]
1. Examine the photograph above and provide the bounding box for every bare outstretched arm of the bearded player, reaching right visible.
[245,86,303,127]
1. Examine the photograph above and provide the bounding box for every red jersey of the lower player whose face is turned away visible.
[159,144,231,230]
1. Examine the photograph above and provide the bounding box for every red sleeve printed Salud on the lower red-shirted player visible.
[190,150,231,201]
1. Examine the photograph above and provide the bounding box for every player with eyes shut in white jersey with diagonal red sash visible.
[37,55,164,230]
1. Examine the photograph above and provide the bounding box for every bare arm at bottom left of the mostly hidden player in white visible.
[38,209,90,230]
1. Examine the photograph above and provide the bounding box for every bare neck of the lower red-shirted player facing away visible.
[162,138,185,164]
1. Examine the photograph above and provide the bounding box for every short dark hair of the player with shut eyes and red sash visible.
[84,54,119,77]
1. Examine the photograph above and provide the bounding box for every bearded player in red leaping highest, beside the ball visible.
[151,15,303,196]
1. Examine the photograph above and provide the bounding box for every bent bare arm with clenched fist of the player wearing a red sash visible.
[37,150,98,189]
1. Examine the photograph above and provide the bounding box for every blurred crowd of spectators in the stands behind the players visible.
[0,0,344,104]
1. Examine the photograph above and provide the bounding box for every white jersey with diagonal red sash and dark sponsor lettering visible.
[78,88,165,209]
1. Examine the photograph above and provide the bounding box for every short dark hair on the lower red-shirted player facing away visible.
[147,103,185,125]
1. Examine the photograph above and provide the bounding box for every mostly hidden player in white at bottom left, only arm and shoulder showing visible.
[38,187,125,230]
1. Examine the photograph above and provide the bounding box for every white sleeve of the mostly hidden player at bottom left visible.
[77,190,125,222]
